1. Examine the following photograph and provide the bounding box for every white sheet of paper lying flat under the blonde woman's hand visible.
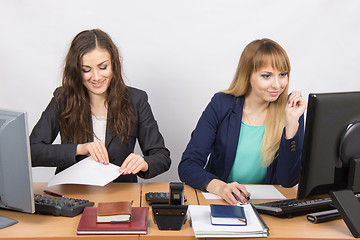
[202,185,286,199]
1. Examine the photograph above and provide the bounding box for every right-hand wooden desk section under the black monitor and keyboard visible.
[196,186,354,240]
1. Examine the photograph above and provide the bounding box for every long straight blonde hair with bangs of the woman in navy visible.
[223,38,290,167]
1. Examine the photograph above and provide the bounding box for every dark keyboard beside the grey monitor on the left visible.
[34,194,94,217]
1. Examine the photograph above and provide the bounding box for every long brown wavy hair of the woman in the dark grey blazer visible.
[57,29,133,143]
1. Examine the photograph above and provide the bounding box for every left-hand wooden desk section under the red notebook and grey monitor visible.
[0,183,141,240]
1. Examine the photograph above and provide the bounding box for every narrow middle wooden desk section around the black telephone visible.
[140,183,198,240]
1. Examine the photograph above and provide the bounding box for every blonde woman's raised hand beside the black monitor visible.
[285,91,307,139]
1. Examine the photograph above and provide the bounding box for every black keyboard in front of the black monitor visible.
[254,194,360,218]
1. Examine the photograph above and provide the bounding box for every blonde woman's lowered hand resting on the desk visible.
[206,179,250,205]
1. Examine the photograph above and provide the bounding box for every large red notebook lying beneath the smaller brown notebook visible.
[77,207,149,235]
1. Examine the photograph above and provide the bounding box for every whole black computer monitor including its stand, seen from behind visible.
[297,92,360,236]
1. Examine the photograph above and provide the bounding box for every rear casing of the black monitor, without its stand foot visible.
[297,92,360,199]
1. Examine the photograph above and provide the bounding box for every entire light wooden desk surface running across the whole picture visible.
[0,183,354,240]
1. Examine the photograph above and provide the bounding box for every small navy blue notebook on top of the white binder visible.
[210,204,246,226]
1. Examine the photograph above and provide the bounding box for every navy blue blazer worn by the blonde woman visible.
[178,93,304,190]
